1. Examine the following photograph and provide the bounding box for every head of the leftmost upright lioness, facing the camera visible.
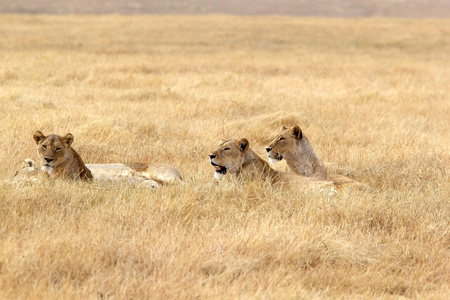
[33,131,74,174]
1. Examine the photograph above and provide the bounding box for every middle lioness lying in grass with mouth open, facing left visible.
[209,138,333,187]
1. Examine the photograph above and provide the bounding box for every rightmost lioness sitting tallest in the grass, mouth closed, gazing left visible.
[266,125,371,189]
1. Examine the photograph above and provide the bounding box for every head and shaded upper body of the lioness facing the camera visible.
[33,131,92,180]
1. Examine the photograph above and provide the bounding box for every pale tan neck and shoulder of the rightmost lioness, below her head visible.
[283,137,327,179]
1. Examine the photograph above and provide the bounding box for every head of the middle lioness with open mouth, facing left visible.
[209,138,249,178]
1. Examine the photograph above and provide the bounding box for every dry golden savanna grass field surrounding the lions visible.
[0,15,450,299]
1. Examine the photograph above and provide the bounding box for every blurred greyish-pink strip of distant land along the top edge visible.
[0,0,450,18]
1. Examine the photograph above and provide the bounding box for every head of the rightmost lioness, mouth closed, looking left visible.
[266,125,303,163]
